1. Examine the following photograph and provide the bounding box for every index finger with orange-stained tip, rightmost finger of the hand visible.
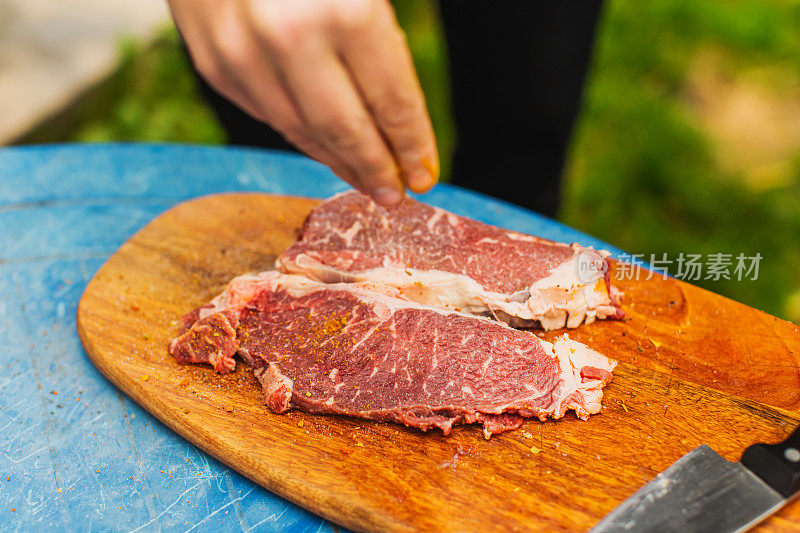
[338,2,439,192]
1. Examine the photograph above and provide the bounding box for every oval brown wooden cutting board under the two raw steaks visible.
[78,194,800,531]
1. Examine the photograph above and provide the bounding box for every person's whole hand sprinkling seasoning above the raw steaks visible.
[168,0,439,205]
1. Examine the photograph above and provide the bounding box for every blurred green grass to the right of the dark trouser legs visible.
[561,0,800,321]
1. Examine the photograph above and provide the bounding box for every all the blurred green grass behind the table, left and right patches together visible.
[17,0,800,321]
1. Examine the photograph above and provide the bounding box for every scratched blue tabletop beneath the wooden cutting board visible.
[0,145,619,532]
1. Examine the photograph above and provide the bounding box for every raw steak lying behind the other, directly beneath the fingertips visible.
[276,192,622,329]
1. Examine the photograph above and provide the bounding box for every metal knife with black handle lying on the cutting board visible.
[590,427,800,533]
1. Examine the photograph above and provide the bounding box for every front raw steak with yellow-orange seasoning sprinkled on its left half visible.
[170,272,615,438]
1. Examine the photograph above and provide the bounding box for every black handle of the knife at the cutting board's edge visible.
[742,427,800,499]
